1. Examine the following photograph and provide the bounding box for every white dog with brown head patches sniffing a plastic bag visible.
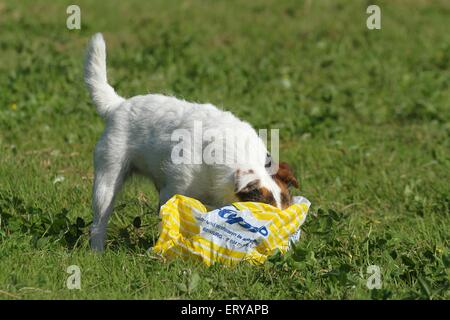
[85,33,298,251]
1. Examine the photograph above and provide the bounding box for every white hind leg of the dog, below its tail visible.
[90,141,128,251]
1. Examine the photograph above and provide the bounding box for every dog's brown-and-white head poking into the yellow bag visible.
[235,162,298,209]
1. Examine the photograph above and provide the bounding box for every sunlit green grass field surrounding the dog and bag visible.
[0,0,450,299]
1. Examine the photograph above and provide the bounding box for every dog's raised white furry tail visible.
[84,33,125,119]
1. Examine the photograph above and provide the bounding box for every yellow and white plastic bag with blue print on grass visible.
[153,195,310,265]
